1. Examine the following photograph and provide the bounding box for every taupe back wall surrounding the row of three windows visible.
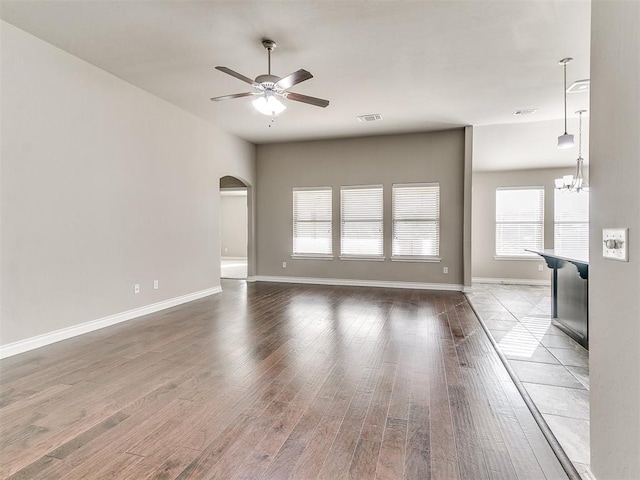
[256,129,465,285]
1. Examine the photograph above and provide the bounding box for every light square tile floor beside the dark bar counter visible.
[467,284,589,478]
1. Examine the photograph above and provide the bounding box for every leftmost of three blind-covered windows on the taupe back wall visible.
[293,187,333,257]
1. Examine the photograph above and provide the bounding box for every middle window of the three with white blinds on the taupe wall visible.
[340,185,383,259]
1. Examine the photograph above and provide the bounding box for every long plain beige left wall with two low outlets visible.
[0,22,255,344]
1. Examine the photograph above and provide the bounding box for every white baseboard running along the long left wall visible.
[0,286,222,358]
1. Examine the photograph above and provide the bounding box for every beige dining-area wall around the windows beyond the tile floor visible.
[471,168,576,281]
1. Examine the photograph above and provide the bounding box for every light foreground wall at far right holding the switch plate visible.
[589,0,640,480]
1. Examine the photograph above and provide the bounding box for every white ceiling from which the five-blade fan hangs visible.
[0,0,590,165]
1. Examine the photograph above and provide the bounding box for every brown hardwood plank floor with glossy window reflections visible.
[0,281,567,480]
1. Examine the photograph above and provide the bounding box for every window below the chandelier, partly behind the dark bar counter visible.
[553,190,589,252]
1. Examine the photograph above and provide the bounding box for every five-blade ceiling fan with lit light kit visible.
[211,39,329,115]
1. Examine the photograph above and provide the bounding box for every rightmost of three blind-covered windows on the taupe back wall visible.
[393,183,440,259]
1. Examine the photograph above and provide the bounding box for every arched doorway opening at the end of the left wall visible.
[220,176,249,279]
